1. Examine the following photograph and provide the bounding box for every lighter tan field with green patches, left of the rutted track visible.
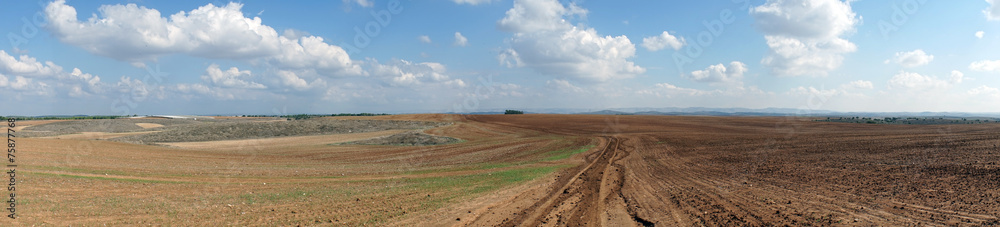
[14,115,586,226]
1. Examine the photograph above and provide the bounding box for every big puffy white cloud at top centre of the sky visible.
[497,0,646,81]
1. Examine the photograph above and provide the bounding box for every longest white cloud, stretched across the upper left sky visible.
[45,0,368,75]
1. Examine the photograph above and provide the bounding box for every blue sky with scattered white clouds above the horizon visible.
[0,0,1000,115]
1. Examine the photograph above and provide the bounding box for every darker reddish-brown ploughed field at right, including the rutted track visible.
[458,116,1000,226]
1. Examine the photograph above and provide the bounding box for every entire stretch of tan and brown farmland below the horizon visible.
[3,114,1000,226]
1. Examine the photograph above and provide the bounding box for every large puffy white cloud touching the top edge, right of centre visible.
[750,0,859,76]
